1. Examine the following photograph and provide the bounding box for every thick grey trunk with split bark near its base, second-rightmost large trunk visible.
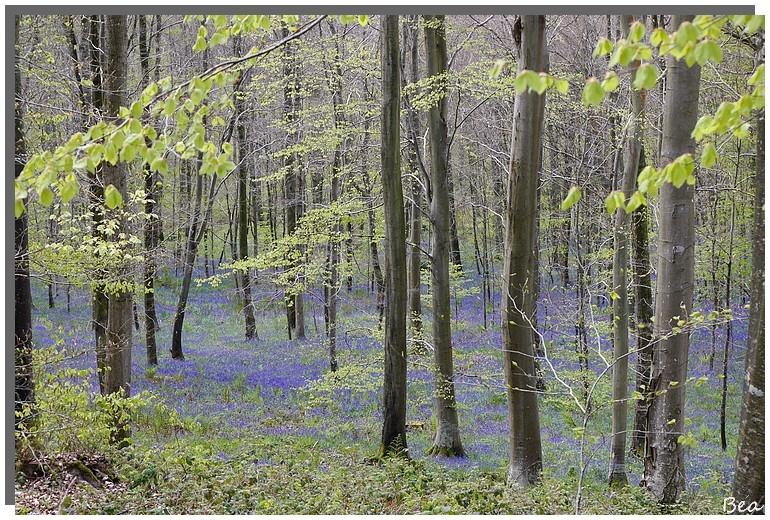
[644,16,700,503]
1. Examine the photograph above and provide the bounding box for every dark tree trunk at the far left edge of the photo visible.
[13,15,36,447]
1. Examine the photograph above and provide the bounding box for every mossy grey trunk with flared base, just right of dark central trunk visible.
[425,15,465,457]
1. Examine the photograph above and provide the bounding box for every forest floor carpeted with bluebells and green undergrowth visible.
[15,273,746,514]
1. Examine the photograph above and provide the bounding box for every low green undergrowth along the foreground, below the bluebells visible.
[40,435,720,514]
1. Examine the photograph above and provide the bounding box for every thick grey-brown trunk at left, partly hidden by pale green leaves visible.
[103,15,133,446]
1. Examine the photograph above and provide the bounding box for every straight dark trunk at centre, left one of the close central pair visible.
[380,15,408,457]
